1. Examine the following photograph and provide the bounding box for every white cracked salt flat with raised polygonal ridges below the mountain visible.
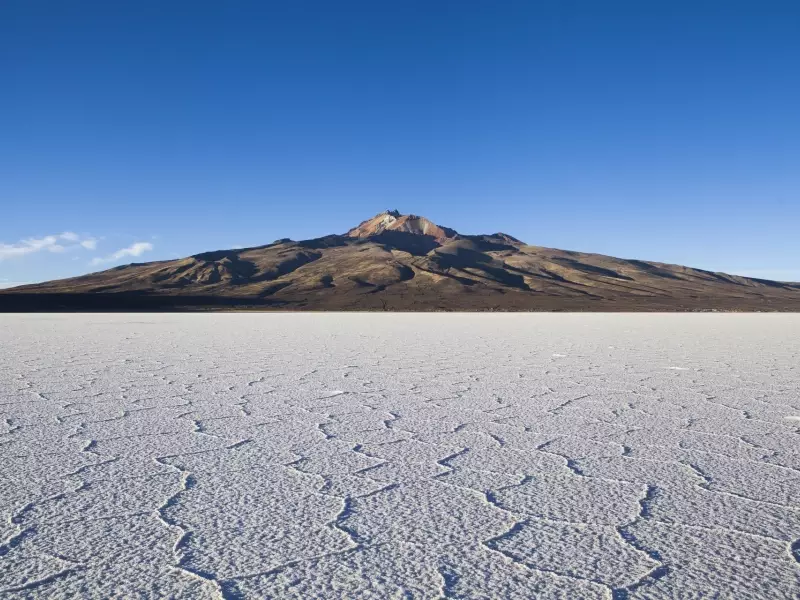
[0,314,800,599]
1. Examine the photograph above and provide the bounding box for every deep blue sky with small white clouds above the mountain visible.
[0,0,800,285]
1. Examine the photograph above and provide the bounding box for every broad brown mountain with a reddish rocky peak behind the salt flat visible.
[0,211,800,311]
